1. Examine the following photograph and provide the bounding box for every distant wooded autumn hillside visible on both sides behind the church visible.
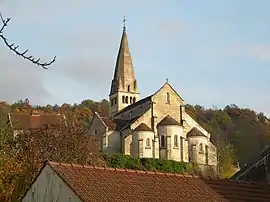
[0,99,270,166]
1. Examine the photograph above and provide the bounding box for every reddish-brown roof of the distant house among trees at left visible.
[9,114,65,129]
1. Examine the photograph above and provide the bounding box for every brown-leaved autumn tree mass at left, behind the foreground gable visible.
[1,125,105,200]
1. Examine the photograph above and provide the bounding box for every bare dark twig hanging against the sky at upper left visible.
[0,13,56,69]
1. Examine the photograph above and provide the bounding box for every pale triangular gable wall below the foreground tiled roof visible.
[22,165,82,202]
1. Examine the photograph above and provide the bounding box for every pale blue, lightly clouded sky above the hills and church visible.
[0,0,270,116]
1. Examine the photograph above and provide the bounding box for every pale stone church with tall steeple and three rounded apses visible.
[90,20,217,167]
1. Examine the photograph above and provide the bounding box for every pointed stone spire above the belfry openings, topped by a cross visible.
[110,17,138,95]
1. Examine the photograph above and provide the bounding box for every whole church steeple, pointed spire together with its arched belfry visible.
[109,17,139,117]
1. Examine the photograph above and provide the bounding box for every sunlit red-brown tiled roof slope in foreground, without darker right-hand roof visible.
[48,162,228,202]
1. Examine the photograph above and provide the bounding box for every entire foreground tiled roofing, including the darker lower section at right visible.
[25,162,270,202]
